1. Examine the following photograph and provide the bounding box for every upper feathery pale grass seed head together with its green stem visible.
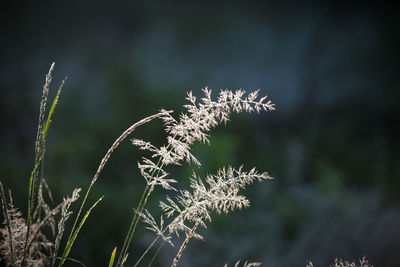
[117,88,275,266]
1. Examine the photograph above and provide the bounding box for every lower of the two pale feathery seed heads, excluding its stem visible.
[160,167,271,239]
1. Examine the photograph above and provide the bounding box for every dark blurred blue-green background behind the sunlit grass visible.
[0,0,400,267]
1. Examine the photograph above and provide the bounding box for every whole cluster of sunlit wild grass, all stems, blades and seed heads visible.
[0,63,372,267]
